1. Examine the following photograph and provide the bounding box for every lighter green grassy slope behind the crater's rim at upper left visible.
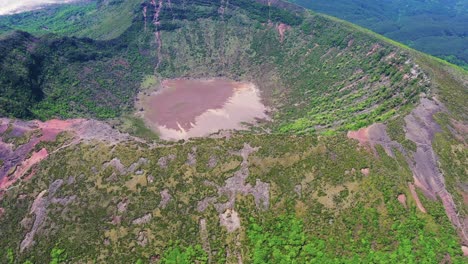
[0,0,141,40]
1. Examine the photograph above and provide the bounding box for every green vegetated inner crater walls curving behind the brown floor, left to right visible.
[0,0,428,133]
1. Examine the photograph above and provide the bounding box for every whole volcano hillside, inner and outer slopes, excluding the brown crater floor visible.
[0,0,468,263]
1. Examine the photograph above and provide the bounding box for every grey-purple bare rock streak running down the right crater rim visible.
[348,98,468,244]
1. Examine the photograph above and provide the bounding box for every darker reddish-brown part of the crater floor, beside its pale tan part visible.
[145,79,239,130]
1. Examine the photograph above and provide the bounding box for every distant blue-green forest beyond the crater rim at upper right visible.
[290,0,468,69]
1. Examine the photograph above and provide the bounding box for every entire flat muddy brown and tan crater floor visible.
[143,79,268,140]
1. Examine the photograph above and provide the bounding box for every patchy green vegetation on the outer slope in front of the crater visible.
[0,135,462,263]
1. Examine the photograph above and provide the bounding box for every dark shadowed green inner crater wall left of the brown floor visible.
[0,24,152,119]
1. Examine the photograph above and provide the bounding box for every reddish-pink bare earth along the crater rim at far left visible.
[0,118,129,194]
